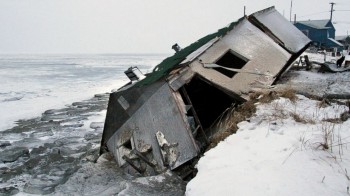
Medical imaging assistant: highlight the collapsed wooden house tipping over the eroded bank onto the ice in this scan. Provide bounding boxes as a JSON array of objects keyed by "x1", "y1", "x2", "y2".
[{"x1": 101, "y1": 7, "x2": 310, "y2": 175}]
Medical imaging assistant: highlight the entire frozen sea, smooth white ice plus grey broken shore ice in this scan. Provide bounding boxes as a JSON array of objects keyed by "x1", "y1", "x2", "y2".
[{"x1": 0, "y1": 54, "x2": 185, "y2": 196}]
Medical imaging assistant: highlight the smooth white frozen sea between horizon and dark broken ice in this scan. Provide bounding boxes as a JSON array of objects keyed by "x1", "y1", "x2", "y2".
[{"x1": 0, "y1": 54, "x2": 165, "y2": 131}]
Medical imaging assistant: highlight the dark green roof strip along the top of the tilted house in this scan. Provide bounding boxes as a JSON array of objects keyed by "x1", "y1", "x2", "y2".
[{"x1": 135, "y1": 17, "x2": 244, "y2": 87}]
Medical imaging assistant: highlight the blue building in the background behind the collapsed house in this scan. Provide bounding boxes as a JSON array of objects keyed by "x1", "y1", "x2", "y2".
[{"x1": 294, "y1": 19, "x2": 344, "y2": 51}]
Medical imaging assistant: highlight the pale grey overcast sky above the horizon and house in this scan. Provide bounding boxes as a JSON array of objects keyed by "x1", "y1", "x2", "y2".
[{"x1": 0, "y1": 0, "x2": 350, "y2": 53}]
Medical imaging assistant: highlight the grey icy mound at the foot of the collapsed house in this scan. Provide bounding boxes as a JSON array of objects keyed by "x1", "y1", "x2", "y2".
[{"x1": 53, "y1": 154, "x2": 185, "y2": 196}]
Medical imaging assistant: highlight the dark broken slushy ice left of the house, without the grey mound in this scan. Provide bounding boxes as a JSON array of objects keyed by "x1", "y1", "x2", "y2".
[{"x1": 0, "y1": 94, "x2": 108, "y2": 194}]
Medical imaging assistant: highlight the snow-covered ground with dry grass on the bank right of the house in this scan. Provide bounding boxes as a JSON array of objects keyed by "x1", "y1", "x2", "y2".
[{"x1": 186, "y1": 54, "x2": 350, "y2": 196}]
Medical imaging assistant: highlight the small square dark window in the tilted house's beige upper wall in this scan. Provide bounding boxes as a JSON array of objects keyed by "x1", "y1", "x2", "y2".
[{"x1": 214, "y1": 50, "x2": 248, "y2": 78}]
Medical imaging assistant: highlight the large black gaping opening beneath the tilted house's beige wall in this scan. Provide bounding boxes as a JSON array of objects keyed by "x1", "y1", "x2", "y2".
[{"x1": 181, "y1": 77, "x2": 235, "y2": 138}]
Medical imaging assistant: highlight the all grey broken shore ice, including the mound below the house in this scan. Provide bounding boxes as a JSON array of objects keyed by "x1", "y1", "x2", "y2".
[{"x1": 0, "y1": 93, "x2": 186, "y2": 195}]
